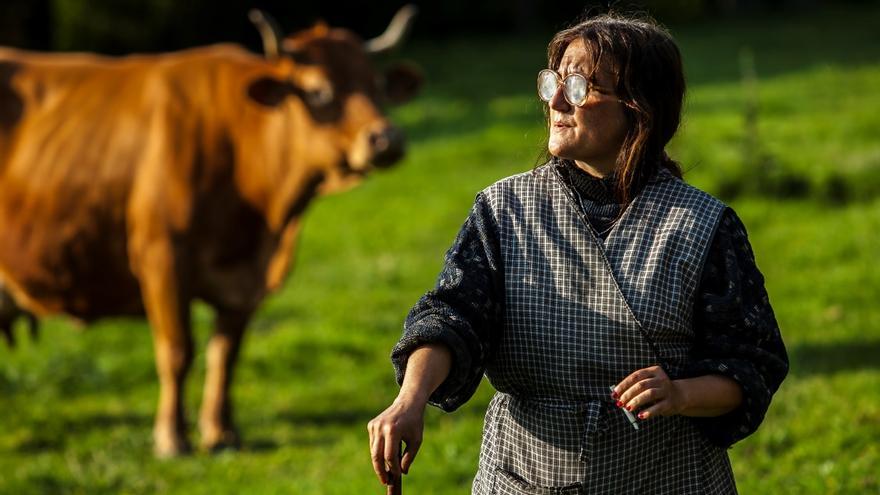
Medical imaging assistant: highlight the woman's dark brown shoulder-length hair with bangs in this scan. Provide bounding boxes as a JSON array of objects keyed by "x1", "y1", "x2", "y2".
[{"x1": 545, "y1": 14, "x2": 685, "y2": 205}]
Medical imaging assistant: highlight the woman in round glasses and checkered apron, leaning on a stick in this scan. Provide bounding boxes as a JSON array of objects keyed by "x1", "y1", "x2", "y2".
[{"x1": 368, "y1": 15, "x2": 788, "y2": 494}]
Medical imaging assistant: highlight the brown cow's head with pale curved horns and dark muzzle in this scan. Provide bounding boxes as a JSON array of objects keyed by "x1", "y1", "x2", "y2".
[{"x1": 248, "y1": 6, "x2": 422, "y2": 192}]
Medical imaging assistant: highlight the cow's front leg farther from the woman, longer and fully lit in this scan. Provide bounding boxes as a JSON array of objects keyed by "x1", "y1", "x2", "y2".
[{"x1": 139, "y1": 243, "x2": 193, "y2": 457}]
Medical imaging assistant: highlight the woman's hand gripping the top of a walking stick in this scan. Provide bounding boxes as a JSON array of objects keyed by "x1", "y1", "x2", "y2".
[{"x1": 367, "y1": 396, "x2": 426, "y2": 485}]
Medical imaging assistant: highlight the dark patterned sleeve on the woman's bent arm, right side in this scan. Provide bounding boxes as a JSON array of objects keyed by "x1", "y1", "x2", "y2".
[{"x1": 682, "y1": 208, "x2": 788, "y2": 447}]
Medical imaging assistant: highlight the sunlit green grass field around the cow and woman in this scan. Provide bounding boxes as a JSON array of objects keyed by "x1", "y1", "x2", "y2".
[{"x1": 0, "y1": 9, "x2": 880, "y2": 494}]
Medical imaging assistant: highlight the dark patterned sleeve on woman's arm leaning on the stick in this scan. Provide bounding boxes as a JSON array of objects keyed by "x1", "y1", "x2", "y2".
[{"x1": 391, "y1": 193, "x2": 504, "y2": 411}]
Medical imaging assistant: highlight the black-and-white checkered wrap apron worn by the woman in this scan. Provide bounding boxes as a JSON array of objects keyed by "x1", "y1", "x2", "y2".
[{"x1": 473, "y1": 165, "x2": 736, "y2": 495}]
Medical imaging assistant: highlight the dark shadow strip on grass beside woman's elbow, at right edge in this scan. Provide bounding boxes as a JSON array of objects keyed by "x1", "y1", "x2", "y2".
[{"x1": 789, "y1": 340, "x2": 880, "y2": 376}]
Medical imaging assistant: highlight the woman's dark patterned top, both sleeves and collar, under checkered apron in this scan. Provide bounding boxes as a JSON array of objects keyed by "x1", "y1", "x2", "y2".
[{"x1": 391, "y1": 165, "x2": 788, "y2": 447}]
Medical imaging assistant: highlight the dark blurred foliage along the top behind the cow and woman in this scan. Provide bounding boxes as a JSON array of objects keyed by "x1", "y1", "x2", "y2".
[{"x1": 0, "y1": 0, "x2": 877, "y2": 53}]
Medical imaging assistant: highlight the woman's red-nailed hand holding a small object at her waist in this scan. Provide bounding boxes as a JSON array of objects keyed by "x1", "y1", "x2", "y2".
[{"x1": 611, "y1": 366, "x2": 685, "y2": 419}]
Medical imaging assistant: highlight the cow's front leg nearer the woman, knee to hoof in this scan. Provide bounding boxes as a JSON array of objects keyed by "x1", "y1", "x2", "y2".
[{"x1": 199, "y1": 310, "x2": 251, "y2": 450}]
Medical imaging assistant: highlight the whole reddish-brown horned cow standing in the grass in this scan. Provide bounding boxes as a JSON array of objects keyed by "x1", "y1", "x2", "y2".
[{"x1": 0, "y1": 7, "x2": 421, "y2": 456}]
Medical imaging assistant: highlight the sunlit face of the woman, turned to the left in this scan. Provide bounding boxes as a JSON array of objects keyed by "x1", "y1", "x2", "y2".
[{"x1": 547, "y1": 39, "x2": 627, "y2": 177}]
